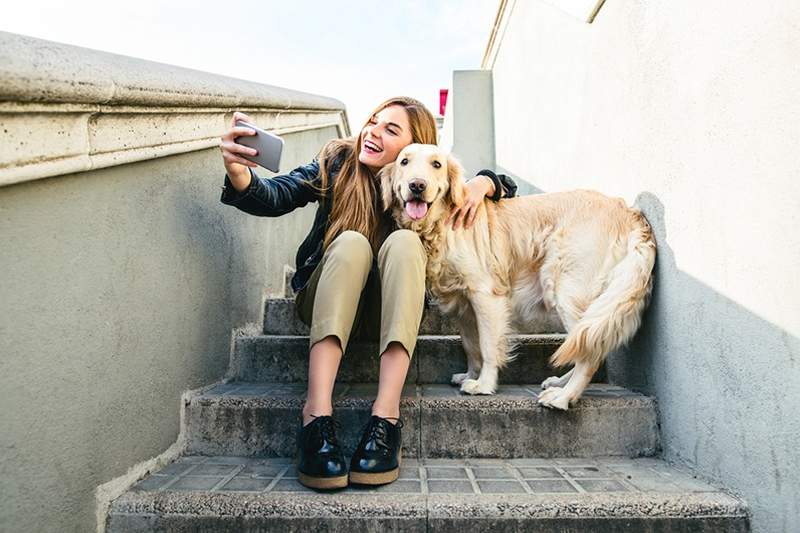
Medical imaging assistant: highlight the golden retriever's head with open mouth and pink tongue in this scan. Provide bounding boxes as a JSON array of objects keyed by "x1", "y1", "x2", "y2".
[{"x1": 379, "y1": 144, "x2": 464, "y2": 228}]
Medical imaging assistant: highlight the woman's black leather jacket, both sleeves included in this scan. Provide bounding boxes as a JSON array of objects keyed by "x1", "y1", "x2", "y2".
[{"x1": 220, "y1": 159, "x2": 517, "y2": 292}]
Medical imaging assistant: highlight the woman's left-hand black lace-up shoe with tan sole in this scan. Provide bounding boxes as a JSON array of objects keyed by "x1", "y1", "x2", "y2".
[{"x1": 297, "y1": 416, "x2": 347, "y2": 489}]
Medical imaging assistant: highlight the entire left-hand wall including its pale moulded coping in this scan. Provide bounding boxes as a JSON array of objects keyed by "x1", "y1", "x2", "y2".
[{"x1": 0, "y1": 34, "x2": 348, "y2": 532}]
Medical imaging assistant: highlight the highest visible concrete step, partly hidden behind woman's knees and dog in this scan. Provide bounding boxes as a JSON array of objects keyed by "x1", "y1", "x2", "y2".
[{"x1": 264, "y1": 298, "x2": 564, "y2": 335}]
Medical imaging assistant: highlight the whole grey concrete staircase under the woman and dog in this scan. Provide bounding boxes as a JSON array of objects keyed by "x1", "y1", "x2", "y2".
[{"x1": 107, "y1": 299, "x2": 750, "y2": 532}]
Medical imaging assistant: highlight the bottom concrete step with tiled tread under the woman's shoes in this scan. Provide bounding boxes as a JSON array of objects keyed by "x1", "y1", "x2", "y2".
[{"x1": 107, "y1": 456, "x2": 750, "y2": 533}]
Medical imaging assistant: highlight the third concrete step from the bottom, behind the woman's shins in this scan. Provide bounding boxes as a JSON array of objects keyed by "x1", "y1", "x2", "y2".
[{"x1": 231, "y1": 334, "x2": 605, "y2": 383}]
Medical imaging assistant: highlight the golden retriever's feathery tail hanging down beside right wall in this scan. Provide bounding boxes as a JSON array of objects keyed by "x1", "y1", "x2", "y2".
[{"x1": 550, "y1": 215, "x2": 656, "y2": 368}]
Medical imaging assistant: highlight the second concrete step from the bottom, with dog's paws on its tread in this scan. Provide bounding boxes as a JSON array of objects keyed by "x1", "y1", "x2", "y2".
[{"x1": 184, "y1": 382, "x2": 659, "y2": 458}]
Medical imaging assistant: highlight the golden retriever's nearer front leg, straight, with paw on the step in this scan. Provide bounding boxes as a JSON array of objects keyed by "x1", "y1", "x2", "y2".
[{"x1": 461, "y1": 292, "x2": 510, "y2": 394}]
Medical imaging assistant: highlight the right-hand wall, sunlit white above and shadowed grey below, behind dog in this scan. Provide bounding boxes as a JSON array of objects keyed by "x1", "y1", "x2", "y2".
[{"x1": 484, "y1": 0, "x2": 800, "y2": 533}]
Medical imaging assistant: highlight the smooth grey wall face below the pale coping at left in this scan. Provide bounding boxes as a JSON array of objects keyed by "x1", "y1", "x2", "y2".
[{"x1": 0, "y1": 92, "x2": 336, "y2": 531}]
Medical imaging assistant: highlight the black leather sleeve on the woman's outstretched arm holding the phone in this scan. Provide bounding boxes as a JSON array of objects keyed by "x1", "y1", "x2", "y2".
[{"x1": 220, "y1": 159, "x2": 320, "y2": 217}]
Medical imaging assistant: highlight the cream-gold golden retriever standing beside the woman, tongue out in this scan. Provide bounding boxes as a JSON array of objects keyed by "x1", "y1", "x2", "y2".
[{"x1": 379, "y1": 144, "x2": 656, "y2": 410}]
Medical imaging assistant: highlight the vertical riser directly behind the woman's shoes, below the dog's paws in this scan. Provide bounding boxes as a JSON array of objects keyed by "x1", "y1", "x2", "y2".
[{"x1": 186, "y1": 398, "x2": 658, "y2": 458}]
